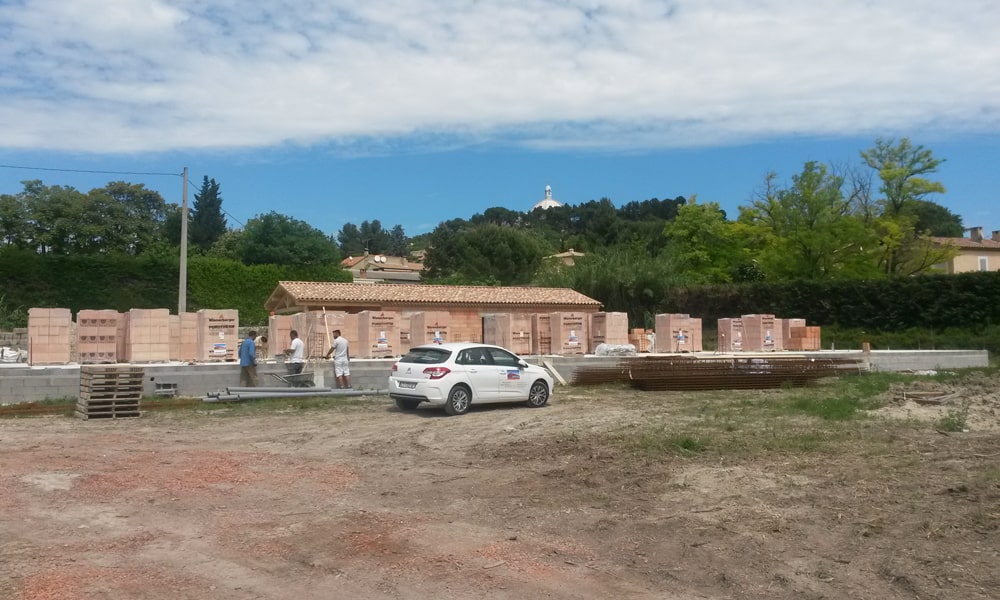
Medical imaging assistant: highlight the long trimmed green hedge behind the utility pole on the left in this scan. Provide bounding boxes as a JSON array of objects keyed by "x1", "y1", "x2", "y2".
[{"x1": 0, "y1": 249, "x2": 351, "y2": 326}]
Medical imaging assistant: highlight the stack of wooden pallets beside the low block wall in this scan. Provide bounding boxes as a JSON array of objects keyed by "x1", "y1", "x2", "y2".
[{"x1": 76, "y1": 365, "x2": 143, "y2": 419}]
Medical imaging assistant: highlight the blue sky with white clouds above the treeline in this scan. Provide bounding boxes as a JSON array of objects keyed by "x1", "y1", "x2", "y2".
[{"x1": 0, "y1": 0, "x2": 1000, "y2": 235}]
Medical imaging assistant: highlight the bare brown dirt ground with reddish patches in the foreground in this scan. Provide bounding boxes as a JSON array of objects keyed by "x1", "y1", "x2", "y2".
[{"x1": 0, "y1": 378, "x2": 1000, "y2": 600}]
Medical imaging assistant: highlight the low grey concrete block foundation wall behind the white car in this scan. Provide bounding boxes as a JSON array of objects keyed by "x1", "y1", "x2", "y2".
[{"x1": 0, "y1": 350, "x2": 989, "y2": 404}]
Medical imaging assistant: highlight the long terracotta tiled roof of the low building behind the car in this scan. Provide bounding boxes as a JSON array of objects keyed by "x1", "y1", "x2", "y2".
[{"x1": 269, "y1": 281, "x2": 601, "y2": 307}]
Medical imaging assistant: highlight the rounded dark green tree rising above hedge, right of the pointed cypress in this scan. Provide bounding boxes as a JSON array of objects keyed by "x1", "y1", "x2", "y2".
[{"x1": 239, "y1": 211, "x2": 340, "y2": 266}]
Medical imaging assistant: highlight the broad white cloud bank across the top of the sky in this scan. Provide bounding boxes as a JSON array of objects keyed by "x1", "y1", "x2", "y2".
[{"x1": 0, "y1": 0, "x2": 1000, "y2": 152}]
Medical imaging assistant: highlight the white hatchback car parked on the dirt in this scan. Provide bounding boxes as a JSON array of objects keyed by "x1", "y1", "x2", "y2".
[{"x1": 389, "y1": 343, "x2": 552, "y2": 415}]
